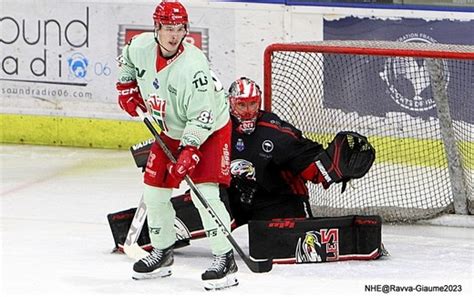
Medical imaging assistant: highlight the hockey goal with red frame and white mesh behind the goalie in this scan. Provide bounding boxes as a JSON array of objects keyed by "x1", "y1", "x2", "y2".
[{"x1": 264, "y1": 41, "x2": 474, "y2": 221}]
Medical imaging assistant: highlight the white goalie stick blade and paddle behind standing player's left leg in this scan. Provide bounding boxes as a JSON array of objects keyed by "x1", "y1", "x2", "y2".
[{"x1": 123, "y1": 195, "x2": 148, "y2": 260}]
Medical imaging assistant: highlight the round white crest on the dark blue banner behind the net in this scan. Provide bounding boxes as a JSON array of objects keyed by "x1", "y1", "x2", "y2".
[{"x1": 379, "y1": 33, "x2": 450, "y2": 111}]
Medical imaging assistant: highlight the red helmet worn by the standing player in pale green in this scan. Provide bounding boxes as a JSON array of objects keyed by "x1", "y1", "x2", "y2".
[{"x1": 153, "y1": 1, "x2": 188, "y2": 27}]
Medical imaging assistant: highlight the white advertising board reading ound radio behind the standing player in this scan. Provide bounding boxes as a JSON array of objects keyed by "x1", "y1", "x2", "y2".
[{"x1": 0, "y1": 1, "x2": 235, "y2": 119}]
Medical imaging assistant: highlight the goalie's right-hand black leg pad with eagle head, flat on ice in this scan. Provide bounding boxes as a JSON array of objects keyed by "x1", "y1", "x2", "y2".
[{"x1": 249, "y1": 216, "x2": 383, "y2": 264}]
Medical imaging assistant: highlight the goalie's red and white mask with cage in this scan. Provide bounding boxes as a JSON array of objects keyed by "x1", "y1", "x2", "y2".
[{"x1": 229, "y1": 77, "x2": 262, "y2": 134}]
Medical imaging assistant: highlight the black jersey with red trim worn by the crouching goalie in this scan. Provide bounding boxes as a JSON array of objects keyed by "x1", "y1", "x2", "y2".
[{"x1": 228, "y1": 111, "x2": 323, "y2": 223}]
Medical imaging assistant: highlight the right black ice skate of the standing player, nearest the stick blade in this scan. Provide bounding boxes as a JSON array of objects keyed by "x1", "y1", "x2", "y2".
[{"x1": 201, "y1": 250, "x2": 239, "y2": 291}]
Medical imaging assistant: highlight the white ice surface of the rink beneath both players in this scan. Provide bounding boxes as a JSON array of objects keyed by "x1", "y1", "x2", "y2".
[{"x1": 0, "y1": 145, "x2": 474, "y2": 297}]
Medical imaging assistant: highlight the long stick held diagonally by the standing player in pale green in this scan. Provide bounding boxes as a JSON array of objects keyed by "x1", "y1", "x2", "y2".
[{"x1": 137, "y1": 108, "x2": 273, "y2": 272}]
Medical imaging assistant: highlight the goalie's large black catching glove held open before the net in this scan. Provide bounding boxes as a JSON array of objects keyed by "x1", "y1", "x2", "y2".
[{"x1": 315, "y1": 132, "x2": 375, "y2": 191}]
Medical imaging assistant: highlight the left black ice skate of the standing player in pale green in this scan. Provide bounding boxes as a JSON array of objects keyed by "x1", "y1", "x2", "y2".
[{"x1": 132, "y1": 246, "x2": 174, "y2": 280}]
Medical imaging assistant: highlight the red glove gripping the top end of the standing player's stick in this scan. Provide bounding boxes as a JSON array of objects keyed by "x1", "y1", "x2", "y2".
[{"x1": 116, "y1": 80, "x2": 146, "y2": 117}]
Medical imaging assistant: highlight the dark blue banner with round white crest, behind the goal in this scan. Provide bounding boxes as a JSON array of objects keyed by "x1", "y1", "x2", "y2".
[{"x1": 324, "y1": 17, "x2": 474, "y2": 123}]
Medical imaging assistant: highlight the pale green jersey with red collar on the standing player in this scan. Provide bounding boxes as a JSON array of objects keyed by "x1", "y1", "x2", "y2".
[{"x1": 118, "y1": 33, "x2": 229, "y2": 147}]
